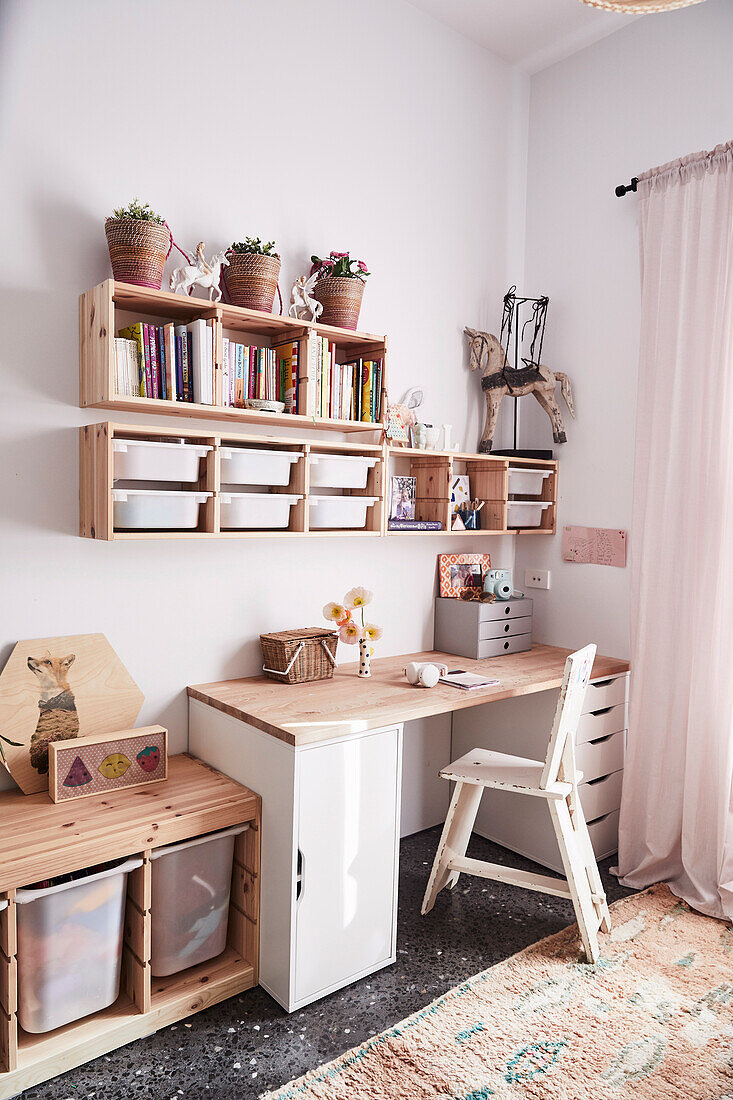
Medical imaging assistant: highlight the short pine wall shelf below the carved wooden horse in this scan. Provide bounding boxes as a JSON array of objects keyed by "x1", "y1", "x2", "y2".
[{"x1": 386, "y1": 447, "x2": 558, "y2": 538}]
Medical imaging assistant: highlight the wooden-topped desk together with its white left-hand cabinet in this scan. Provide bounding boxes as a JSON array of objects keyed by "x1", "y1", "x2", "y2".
[{"x1": 188, "y1": 646, "x2": 630, "y2": 1011}]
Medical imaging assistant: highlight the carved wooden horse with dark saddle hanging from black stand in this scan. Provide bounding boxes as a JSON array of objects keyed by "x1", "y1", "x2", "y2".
[{"x1": 463, "y1": 328, "x2": 576, "y2": 454}]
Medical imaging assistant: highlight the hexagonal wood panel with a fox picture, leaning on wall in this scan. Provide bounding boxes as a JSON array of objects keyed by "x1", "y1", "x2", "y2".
[{"x1": 0, "y1": 634, "x2": 145, "y2": 794}]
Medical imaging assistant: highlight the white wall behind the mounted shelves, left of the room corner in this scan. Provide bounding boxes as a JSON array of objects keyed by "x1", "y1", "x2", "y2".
[{"x1": 0, "y1": 0, "x2": 524, "y2": 787}]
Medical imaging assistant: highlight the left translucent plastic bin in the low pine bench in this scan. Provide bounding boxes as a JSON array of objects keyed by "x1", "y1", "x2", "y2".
[{"x1": 15, "y1": 859, "x2": 142, "y2": 1034}]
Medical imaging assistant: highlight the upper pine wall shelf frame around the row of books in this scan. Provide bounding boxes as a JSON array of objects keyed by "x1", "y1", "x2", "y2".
[{"x1": 79, "y1": 279, "x2": 387, "y2": 433}]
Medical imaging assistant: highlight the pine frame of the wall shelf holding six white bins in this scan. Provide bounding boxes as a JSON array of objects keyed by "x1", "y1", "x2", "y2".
[{"x1": 79, "y1": 421, "x2": 385, "y2": 541}]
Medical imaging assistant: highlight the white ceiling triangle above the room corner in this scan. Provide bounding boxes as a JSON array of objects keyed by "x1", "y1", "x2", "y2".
[{"x1": 409, "y1": 0, "x2": 638, "y2": 73}]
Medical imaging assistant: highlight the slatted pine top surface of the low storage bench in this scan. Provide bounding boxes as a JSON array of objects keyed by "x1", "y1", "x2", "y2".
[{"x1": 0, "y1": 754, "x2": 260, "y2": 893}]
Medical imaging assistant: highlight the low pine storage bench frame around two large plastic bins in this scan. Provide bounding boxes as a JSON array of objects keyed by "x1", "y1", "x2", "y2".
[{"x1": 0, "y1": 755, "x2": 261, "y2": 1100}]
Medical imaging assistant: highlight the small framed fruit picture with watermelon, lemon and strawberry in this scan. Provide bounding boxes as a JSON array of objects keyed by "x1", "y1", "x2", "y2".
[{"x1": 48, "y1": 726, "x2": 168, "y2": 802}]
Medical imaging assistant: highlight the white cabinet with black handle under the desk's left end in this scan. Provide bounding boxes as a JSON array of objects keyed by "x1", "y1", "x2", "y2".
[{"x1": 189, "y1": 700, "x2": 402, "y2": 1012}]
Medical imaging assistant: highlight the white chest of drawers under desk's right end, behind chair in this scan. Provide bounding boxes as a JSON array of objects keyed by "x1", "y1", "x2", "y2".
[{"x1": 451, "y1": 672, "x2": 628, "y2": 873}]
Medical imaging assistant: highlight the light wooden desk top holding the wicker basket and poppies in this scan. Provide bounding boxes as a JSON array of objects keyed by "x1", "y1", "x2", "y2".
[{"x1": 188, "y1": 646, "x2": 630, "y2": 747}]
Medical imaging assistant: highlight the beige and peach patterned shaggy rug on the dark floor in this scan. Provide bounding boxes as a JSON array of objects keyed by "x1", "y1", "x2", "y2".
[{"x1": 267, "y1": 886, "x2": 733, "y2": 1100}]
